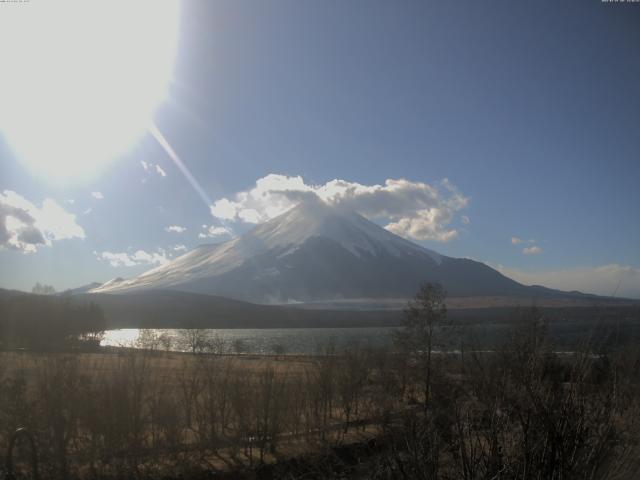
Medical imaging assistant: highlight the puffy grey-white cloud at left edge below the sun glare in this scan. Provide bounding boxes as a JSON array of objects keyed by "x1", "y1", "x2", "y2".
[{"x1": 0, "y1": 190, "x2": 85, "y2": 253}]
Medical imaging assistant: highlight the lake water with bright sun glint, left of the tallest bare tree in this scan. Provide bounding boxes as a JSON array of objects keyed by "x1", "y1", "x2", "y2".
[{"x1": 101, "y1": 327, "x2": 395, "y2": 354}]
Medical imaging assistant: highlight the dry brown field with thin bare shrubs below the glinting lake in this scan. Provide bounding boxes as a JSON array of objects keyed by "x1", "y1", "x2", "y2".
[{"x1": 0, "y1": 349, "x2": 396, "y2": 478}]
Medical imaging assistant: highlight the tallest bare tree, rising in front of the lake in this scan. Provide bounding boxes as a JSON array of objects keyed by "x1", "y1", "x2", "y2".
[{"x1": 394, "y1": 283, "x2": 447, "y2": 410}]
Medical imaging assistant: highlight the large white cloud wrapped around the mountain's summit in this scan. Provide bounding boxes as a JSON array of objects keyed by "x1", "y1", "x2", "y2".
[{"x1": 211, "y1": 174, "x2": 469, "y2": 242}]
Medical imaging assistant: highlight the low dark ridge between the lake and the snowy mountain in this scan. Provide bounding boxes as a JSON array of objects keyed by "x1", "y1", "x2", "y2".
[{"x1": 0, "y1": 289, "x2": 640, "y2": 329}]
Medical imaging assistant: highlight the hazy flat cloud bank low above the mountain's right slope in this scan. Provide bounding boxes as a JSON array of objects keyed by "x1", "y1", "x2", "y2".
[{"x1": 495, "y1": 263, "x2": 640, "y2": 298}]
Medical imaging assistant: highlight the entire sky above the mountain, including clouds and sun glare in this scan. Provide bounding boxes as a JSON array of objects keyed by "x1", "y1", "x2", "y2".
[{"x1": 0, "y1": 0, "x2": 640, "y2": 298}]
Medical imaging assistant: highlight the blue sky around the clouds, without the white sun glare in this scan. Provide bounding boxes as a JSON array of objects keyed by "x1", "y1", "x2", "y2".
[{"x1": 0, "y1": 0, "x2": 640, "y2": 297}]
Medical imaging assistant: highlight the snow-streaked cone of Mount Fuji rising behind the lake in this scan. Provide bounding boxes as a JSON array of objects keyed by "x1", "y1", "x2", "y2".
[{"x1": 91, "y1": 202, "x2": 576, "y2": 303}]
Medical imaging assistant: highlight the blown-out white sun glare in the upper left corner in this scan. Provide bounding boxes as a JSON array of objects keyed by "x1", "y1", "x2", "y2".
[{"x1": 0, "y1": 0, "x2": 179, "y2": 183}]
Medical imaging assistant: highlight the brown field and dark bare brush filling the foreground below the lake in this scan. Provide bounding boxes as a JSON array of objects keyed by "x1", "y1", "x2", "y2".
[{"x1": 0, "y1": 285, "x2": 640, "y2": 480}]
